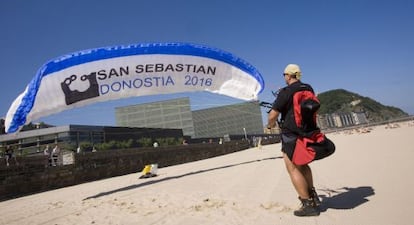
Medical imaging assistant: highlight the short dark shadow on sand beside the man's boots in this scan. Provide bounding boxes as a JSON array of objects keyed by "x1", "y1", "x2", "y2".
[{"x1": 318, "y1": 186, "x2": 375, "y2": 212}]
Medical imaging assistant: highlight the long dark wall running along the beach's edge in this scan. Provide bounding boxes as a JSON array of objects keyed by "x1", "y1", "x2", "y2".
[{"x1": 0, "y1": 141, "x2": 249, "y2": 200}]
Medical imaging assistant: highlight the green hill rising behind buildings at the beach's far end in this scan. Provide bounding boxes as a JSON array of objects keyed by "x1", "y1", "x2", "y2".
[{"x1": 318, "y1": 89, "x2": 408, "y2": 122}]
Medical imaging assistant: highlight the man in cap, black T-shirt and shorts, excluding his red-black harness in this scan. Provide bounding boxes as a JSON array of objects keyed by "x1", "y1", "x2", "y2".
[{"x1": 267, "y1": 64, "x2": 320, "y2": 216}]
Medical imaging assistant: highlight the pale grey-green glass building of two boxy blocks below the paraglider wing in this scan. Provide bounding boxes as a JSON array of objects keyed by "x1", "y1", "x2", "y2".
[{"x1": 115, "y1": 97, "x2": 263, "y2": 138}]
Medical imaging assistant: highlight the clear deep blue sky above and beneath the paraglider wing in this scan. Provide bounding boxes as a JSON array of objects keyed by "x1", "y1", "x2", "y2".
[{"x1": 0, "y1": 0, "x2": 414, "y2": 125}]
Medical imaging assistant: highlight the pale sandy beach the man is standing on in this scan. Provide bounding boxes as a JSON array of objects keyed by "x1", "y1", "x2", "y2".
[{"x1": 0, "y1": 122, "x2": 414, "y2": 225}]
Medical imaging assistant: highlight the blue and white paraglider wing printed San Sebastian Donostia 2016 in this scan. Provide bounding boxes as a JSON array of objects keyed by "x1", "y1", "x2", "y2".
[{"x1": 5, "y1": 43, "x2": 264, "y2": 133}]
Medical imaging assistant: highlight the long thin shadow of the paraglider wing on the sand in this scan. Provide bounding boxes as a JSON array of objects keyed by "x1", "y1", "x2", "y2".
[{"x1": 83, "y1": 157, "x2": 283, "y2": 201}]
